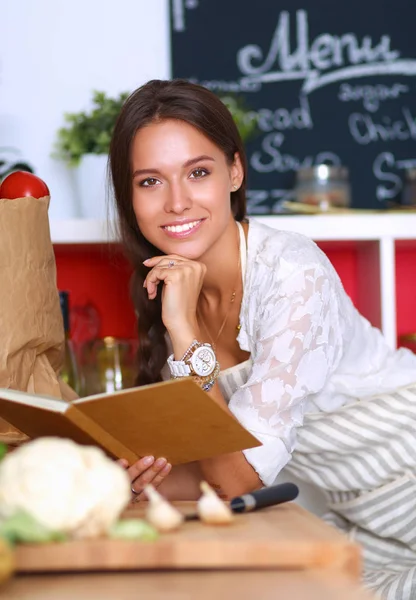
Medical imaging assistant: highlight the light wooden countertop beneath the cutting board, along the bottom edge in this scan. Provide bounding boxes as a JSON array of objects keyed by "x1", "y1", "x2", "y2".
[{"x1": 0, "y1": 571, "x2": 376, "y2": 600}]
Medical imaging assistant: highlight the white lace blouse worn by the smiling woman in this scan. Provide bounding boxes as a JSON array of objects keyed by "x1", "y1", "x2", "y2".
[{"x1": 231, "y1": 219, "x2": 416, "y2": 485}]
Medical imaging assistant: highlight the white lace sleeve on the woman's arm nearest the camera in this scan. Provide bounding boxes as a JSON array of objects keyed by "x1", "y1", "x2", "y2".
[{"x1": 229, "y1": 264, "x2": 342, "y2": 485}]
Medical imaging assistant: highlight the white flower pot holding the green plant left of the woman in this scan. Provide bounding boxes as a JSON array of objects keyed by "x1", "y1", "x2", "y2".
[{"x1": 74, "y1": 154, "x2": 114, "y2": 220}]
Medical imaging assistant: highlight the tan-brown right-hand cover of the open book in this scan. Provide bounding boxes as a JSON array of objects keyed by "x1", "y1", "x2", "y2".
[{"x1": 73, "y1": 378, "x2": 261, "y2": 464}]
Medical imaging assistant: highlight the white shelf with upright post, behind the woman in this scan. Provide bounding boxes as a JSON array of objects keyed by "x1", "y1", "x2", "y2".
[{"x1": 50, "y1": 212, "x2": 416, "y2": 348}]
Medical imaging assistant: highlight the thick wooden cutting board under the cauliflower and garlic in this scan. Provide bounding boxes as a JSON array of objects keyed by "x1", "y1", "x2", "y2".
[{"x1": 16, "y1": 503, "x2": 361, "y2": 578}]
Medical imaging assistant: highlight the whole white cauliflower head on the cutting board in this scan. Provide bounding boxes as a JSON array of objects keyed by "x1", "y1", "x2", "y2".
[{"x1": 0, "y1": 437, "x2": 131, "y2": 538}]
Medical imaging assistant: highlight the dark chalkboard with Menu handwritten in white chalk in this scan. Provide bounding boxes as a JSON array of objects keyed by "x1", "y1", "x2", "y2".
[{"x1": 170, "y1": 0, "x2": 416, "y2": 214}]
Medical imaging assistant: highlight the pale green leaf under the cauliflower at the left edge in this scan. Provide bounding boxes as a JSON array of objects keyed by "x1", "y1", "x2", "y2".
[{"x1": 0, "y1": 511, "x2": 67, "y2": 544}]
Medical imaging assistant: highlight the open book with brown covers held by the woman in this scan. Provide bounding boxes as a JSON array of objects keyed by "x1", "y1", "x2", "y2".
[{"x1": 0, "y1": 378, "x2": 261, "y2": 464}]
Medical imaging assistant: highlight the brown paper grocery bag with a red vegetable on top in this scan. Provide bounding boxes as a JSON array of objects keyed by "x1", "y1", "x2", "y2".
[{"x1": 0, "y1": 197, "x2": 64, "y2": 443}]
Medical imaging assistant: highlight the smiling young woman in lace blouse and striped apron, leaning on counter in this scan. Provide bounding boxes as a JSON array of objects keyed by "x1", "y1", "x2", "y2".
[{"x1": 110, "y1": 81, "x2": 416, "y2": 599}]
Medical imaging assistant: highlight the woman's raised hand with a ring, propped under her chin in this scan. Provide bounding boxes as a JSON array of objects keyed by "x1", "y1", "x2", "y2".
[{"x1": 144, "y1": 254, "x2": 206, "y2": 349}]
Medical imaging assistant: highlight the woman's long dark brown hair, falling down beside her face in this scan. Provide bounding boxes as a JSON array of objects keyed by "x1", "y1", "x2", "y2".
[{"x1": 109, "y1": 79, "x2": 247, "y2": 385}]
